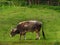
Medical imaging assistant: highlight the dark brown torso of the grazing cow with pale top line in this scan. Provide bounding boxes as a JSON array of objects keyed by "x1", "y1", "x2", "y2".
[{"x1": 17, "y1": 21, "x2": 41, "y2": 31}]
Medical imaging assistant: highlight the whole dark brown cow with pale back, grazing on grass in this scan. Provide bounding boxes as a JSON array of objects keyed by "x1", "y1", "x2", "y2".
[{"x1": 10, "y1": 20, "x2": 45, "y2": 40}]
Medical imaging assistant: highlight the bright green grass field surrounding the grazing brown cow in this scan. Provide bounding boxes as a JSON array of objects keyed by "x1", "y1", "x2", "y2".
[{"x1": 0, "y1": 5, "x2": 60, "y2": 45}]
